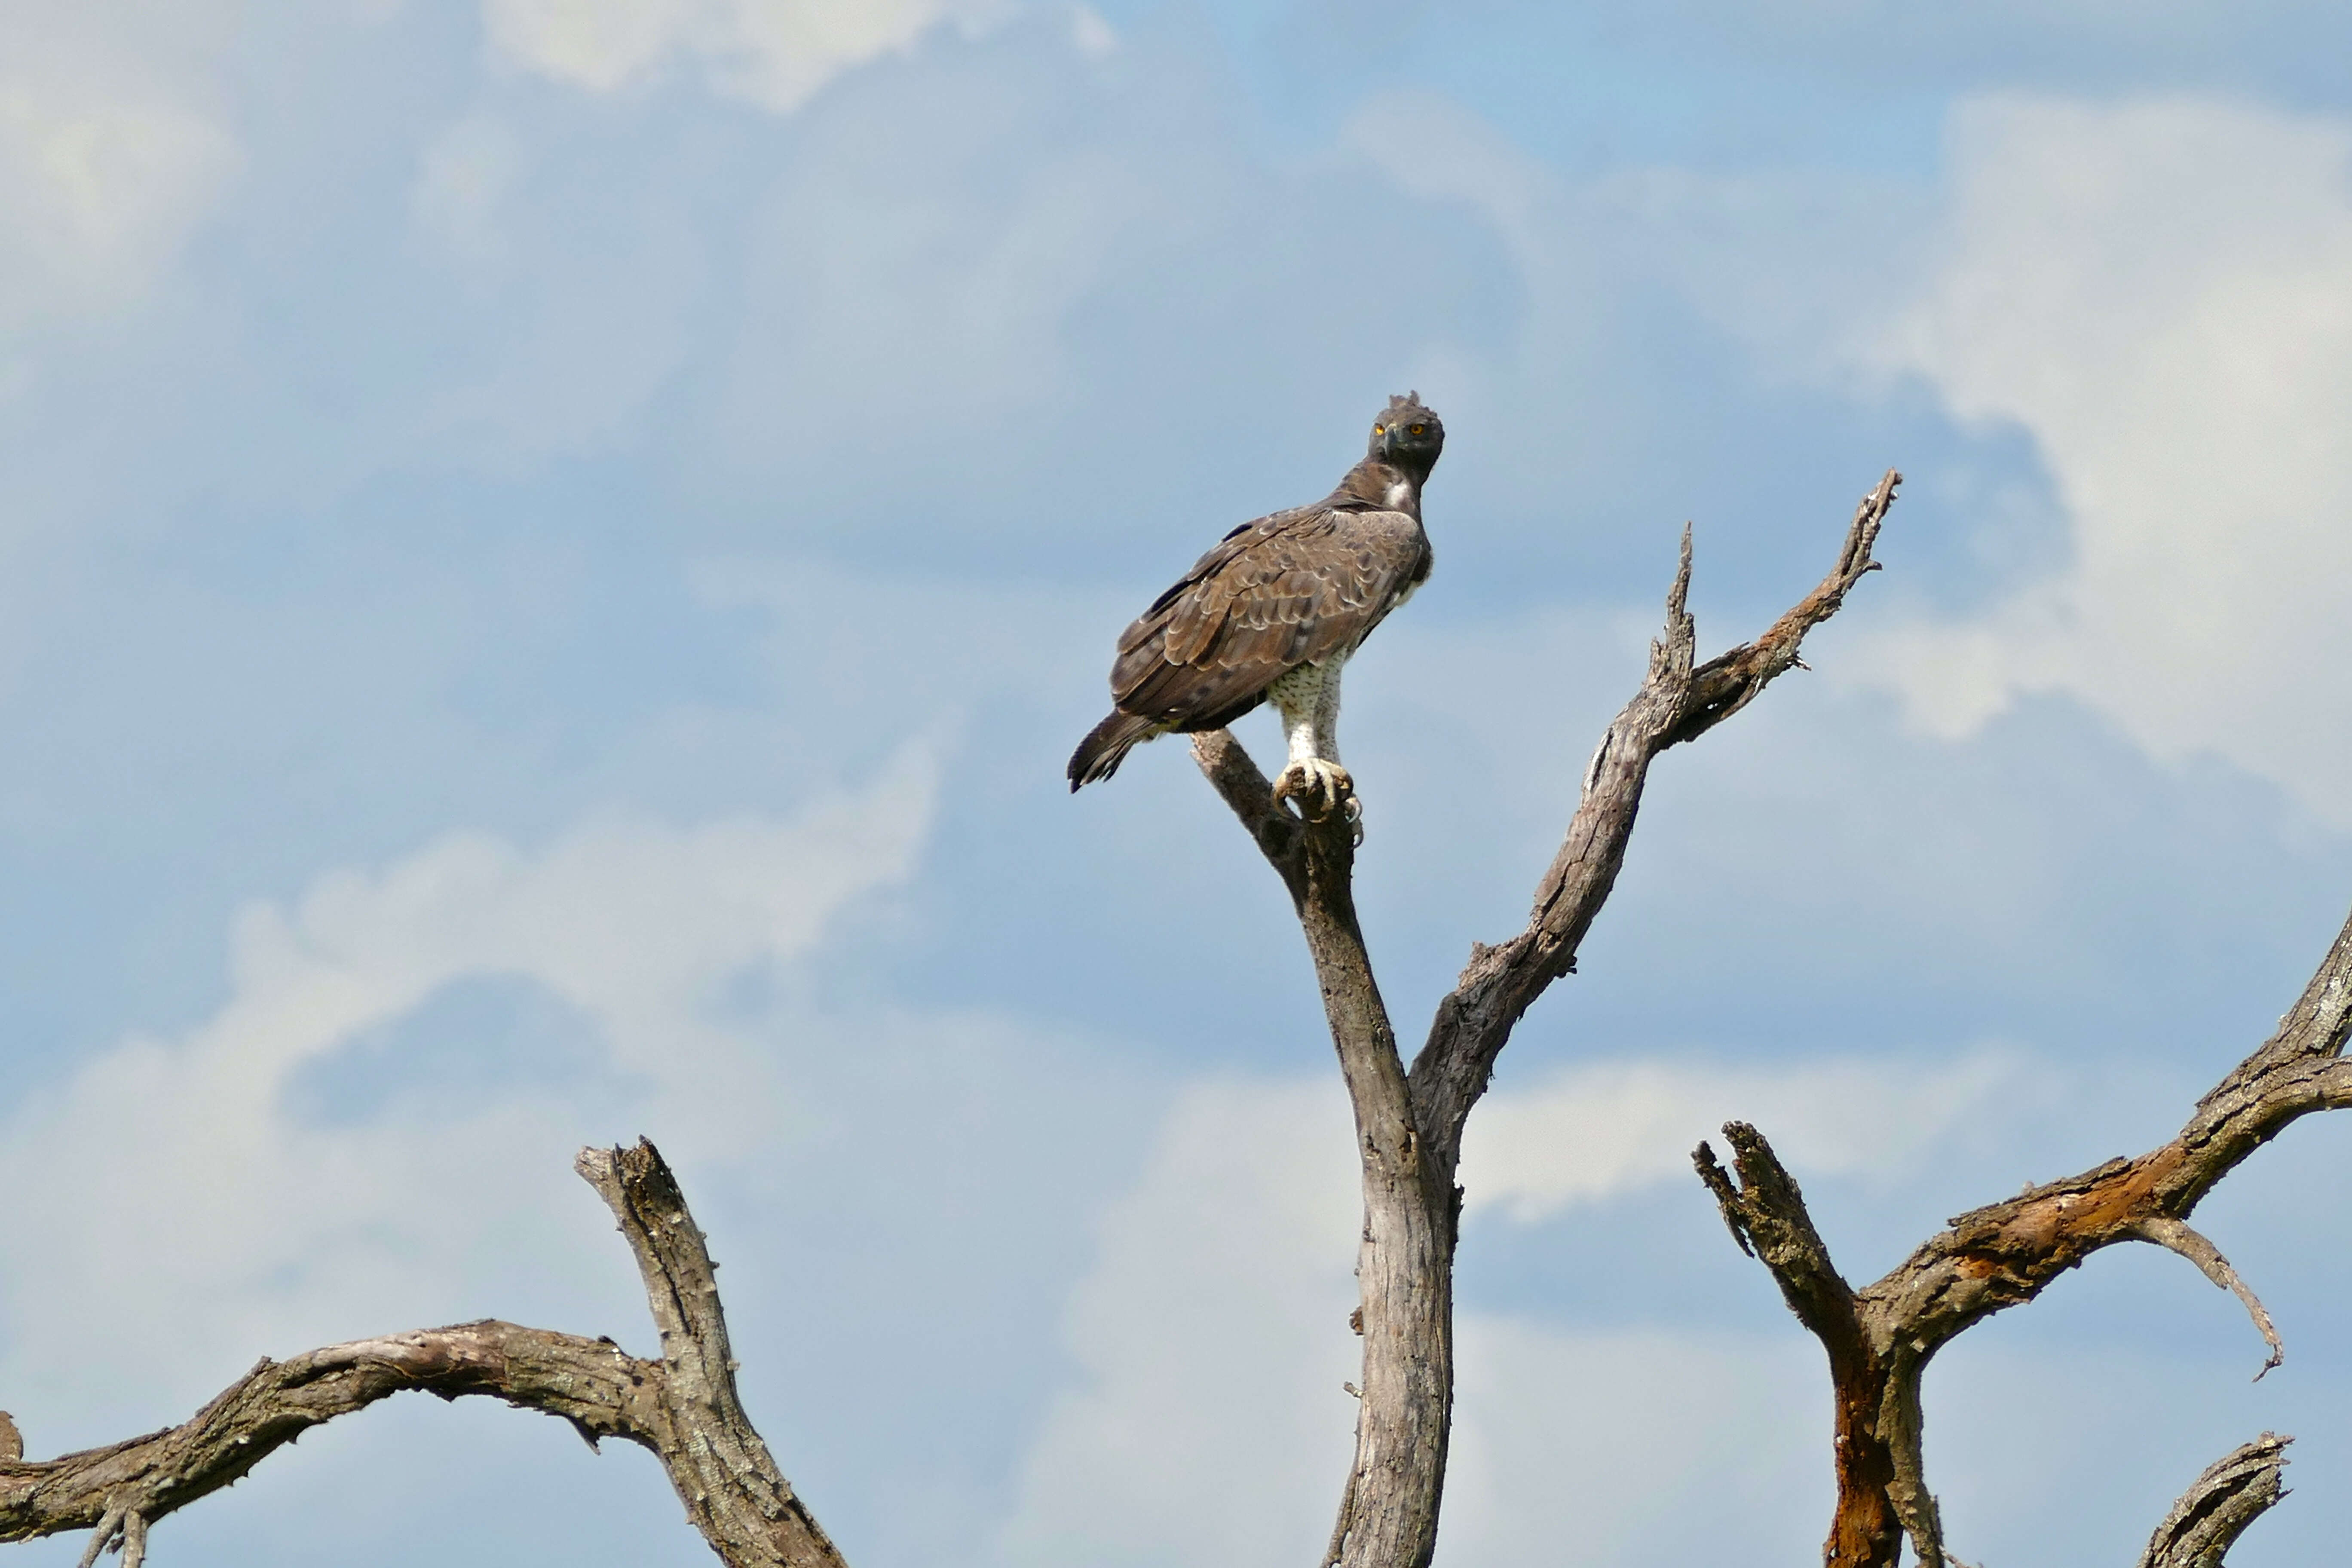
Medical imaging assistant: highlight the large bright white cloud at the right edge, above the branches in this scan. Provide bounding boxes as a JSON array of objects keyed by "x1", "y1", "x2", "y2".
[{"x1": 1858, "y1": 99, "x2": 2352, "y2": 825}]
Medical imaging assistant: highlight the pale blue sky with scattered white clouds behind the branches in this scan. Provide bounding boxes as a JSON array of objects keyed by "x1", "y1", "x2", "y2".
[{"x1": 0, "y1": 0, "x2": 2352, "y2": 1568}]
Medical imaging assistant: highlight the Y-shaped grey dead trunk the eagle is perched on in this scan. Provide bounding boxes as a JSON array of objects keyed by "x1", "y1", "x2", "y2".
[{"x1": 1192, "y1": 472, "x2": 1903, "y2": 1568}]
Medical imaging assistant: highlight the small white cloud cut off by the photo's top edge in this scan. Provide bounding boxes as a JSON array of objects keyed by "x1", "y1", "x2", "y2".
[{"x1": 482, "y1": 0, "x2": 978, "y2": 113}]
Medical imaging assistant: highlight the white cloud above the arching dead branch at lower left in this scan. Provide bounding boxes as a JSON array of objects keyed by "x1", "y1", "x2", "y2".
[{"x1": 0, "y1": 752, "x2": 931, "y2": 1436}]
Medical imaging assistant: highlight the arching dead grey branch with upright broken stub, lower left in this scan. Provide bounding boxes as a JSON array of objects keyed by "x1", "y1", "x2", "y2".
[{"x1": 0, "y1": 1140, "x2": 842, "y2": 1568}]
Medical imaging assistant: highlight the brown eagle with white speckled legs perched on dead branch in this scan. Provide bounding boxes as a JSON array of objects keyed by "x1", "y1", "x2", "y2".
[{"x1": 1070, "y1": 392, "x2": 1446, "y2": 811}]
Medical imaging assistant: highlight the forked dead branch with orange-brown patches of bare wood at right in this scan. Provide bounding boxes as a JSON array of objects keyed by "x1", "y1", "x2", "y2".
[{"x1": 1696, "y1": 903, "x2": 2352, "y2": 1568}]
